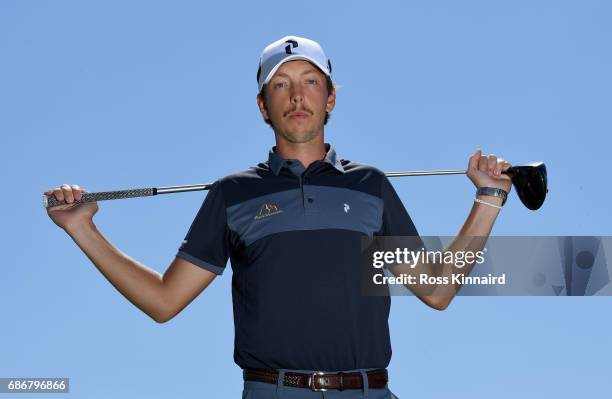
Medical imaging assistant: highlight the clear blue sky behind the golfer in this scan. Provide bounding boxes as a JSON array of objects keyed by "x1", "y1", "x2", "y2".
[{"x1": 0, "y1": 1, "x2": 612, "y2": 399}]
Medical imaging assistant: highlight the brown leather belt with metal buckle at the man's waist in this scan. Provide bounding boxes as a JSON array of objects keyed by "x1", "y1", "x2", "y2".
[{"x1": 242, "y1": 369, "x2": 388, "y2": 391}]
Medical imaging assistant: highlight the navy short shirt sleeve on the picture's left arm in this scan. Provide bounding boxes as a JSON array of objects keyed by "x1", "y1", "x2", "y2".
[{"x1": 176, "y1": 180, "x2": 231, "y2": 275}]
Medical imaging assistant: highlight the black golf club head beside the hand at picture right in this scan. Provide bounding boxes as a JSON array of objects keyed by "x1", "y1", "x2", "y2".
[{"x1": 505, "y1": 162, "x2": 548, "y2": 211}]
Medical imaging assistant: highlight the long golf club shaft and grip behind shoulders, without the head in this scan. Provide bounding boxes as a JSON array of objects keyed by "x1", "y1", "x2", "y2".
[{"x1": 43, "y1": 170, "x2": 504, "y2": 208}]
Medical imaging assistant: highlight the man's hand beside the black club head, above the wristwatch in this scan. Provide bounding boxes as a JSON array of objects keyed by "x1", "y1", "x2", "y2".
[{"x1": 467, "y1": 148, "x2": 512, "y2": 193}]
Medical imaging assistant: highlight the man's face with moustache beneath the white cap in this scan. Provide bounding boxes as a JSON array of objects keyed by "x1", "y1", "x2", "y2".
[{"x1": 257, "y1": 60, "x2": 336, "y2": 143}]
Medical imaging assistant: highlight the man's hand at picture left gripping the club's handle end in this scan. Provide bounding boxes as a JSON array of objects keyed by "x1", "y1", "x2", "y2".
[{"x1": 45, "y1": 184, "x2": 98, "y2": 232}]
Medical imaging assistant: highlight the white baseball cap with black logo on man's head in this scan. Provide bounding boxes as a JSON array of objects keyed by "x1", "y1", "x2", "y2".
[{"x1": 257, "y1": 36, "x2": 331, "y2": 91}]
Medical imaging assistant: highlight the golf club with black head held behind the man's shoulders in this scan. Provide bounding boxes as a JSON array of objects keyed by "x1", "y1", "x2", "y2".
[{"x1": 43, "y1": 162, "x2": 548, "y2": 211}]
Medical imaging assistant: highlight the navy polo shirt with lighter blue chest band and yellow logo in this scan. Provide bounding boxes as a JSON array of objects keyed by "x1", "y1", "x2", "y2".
[{"x1": 177, "y1": 143, "x2": 418, "y2": 371}]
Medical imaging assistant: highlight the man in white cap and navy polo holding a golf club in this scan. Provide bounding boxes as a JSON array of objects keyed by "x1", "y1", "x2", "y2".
[{"x1": 47, "y1": 36, "x2": 511, "y2": 399}]
